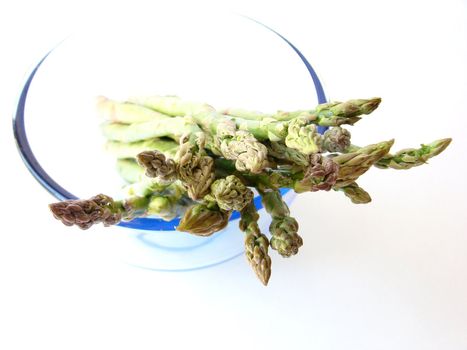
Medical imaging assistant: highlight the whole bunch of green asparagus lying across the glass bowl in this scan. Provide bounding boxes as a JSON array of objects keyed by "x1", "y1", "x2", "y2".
[{"x1": 50, "y1": 96, "x2": 451, "y2": 285}]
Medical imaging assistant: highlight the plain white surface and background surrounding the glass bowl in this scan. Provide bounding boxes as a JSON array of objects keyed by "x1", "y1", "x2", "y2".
[{"x1": 0, "y1": 1, "x2": 467, "y2": 350}]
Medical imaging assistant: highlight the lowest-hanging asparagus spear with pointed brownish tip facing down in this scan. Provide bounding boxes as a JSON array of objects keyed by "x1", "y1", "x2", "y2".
[{"x1": 239, "y1": 202, "x2": 271, "y2": 286}]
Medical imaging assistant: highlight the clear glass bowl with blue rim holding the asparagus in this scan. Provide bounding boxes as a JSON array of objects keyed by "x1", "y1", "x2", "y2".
[{"x1": 14, "y1": 13, "x2": 326, "y2": 271}]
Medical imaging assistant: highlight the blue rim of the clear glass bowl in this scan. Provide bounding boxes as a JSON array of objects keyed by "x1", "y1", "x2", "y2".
[{"x1": 13, "y1": 16, "x2": 327, "y2": 231}]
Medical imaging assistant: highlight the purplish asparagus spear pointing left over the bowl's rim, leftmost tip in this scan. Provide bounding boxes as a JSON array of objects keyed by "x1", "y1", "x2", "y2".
[{"x1": 49, "y1": 194, "x2": 148, "y2": 230}]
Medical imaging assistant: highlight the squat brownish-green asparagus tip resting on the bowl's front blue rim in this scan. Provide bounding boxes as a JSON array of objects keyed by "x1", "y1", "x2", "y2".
[{"x1": 177, "y1": 203, "x2": 232, "y2": 236}]
